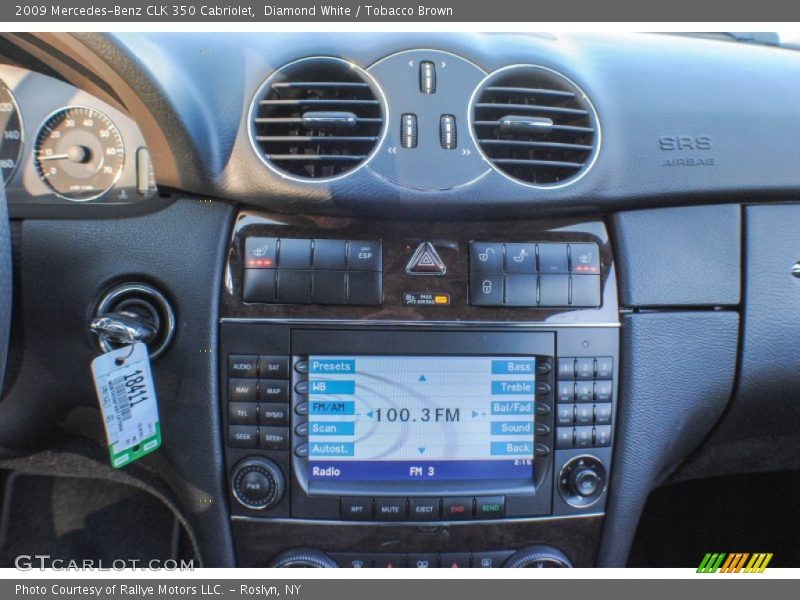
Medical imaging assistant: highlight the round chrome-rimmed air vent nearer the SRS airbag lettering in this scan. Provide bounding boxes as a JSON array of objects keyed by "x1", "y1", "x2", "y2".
[{"x1": 470, "y1": 65, "x2": 600, "y2": 188}]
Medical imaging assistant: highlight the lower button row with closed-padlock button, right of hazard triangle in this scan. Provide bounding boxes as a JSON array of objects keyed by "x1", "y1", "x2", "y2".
[{"x1": 469, "y1": 271, "x2": 600, "y2": 308}]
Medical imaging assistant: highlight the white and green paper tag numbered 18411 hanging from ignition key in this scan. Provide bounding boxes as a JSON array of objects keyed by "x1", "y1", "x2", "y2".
[{"x1": 92, "y1": 343, "x2": 161, "y2": 469}]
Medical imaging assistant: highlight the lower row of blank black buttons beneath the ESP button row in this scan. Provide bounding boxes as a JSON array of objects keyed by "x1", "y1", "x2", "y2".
[{"x1": 242, "y1": 269, "x2": 383, "y2": 306}]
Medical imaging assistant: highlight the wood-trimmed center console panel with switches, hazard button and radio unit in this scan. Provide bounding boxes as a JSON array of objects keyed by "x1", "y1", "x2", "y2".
[{"x1": 220, "y1": 213, "x2": 619, "y2": 567}]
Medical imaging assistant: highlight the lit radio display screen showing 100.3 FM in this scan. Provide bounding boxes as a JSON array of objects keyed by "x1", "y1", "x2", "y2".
[{"x1": 308, "y1": 356, "x2": 536, "y2": 482}]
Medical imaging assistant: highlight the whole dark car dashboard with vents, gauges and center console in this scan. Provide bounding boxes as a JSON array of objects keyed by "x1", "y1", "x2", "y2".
[{"x1": 0, "y1": 33, "x2": 800, "y2": 568}]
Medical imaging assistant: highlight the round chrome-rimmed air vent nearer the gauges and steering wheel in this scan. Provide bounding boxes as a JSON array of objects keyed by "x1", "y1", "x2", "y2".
[{"x1": 250, "y1": 57, "x2": 385, "y2": 181}]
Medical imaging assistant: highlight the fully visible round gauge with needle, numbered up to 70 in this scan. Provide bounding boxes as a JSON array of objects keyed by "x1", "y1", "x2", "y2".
[{"x1": 34, "y1": 106, "x2": 125, "y2": 202}]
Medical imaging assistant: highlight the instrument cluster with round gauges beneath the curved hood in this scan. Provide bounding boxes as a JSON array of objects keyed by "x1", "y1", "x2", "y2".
[{"x1": 0, "y1": 64, "x2": 156, "y2": 210}]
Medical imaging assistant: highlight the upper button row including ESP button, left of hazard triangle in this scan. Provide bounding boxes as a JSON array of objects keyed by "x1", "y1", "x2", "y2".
[{"x1": 244, "y1": 237, "x2": 383, "y2": 271}]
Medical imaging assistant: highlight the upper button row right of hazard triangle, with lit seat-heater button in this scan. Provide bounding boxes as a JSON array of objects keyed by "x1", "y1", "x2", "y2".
[{"x1": 469, "y1": 242, "x2": 600, "y2": 275}]
